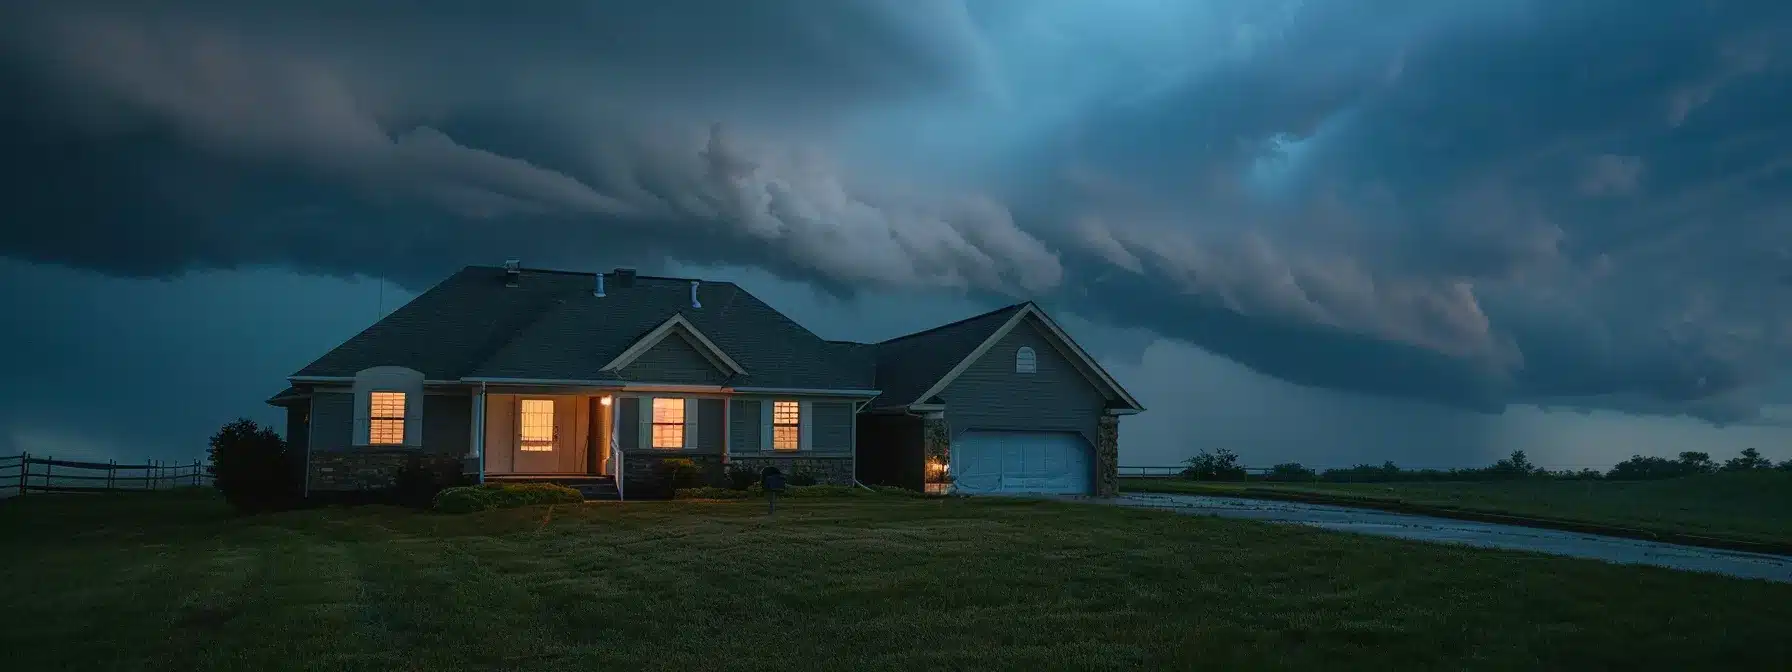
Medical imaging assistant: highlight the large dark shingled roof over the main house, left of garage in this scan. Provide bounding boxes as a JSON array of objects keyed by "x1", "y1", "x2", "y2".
[{"x1": 297, "y1": 267, "x2": 874, "y2": 389}]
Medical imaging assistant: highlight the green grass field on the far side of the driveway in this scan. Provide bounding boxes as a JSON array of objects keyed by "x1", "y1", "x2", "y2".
[{"x1": 1120, "y1": 471, "x2": 1792, "y2": 543}]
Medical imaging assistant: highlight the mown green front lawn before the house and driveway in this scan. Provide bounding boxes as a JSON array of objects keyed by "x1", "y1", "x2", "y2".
[{"x1": 0, "y1": 493, "x2": 1792, "y2": 670}]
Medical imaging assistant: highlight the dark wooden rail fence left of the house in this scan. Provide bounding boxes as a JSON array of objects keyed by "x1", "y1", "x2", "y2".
[{"x1": 0, "y1": 453, "x2": 211, "y2": 495}]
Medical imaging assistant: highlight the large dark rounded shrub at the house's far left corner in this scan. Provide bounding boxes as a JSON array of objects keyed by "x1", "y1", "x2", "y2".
[{"x1": 206, "y1": 418, "x2": 303, "y2": 513}]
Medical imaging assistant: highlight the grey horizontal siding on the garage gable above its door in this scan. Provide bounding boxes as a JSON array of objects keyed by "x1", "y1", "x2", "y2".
[{"x1": 941, "y1": 317, "x2": 1107, "y2": 446}]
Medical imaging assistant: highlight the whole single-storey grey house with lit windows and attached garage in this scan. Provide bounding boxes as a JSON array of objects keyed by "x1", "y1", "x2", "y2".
[{"x1": 269, "y1": 262, "x2": 1143, "y2": 498}]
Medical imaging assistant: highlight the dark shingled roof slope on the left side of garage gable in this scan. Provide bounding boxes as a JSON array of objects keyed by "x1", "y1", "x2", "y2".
[{"x1": 873, "y1": 303, "x2": 1027, "y2": 407}]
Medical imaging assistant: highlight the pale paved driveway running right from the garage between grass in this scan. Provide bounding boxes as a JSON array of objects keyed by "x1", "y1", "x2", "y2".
[{"x1": 1113, "y1": 493, "x2": 1792, "y2": 582}]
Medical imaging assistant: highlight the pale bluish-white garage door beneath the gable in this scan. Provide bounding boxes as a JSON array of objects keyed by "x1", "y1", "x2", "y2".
[{"x1": 952, "y1": 430, "x2": 1093, "y2": 495}]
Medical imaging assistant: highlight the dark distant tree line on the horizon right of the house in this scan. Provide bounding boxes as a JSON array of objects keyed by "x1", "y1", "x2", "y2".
[{"x1": 1183, "y1": 448, "x2": 1792, "y2": 482}]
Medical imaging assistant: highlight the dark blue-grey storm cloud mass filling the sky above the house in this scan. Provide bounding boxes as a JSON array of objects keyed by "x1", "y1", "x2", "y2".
[{"x1": 0, "y1": 0, "x2": 1792, "y2": 421}]
